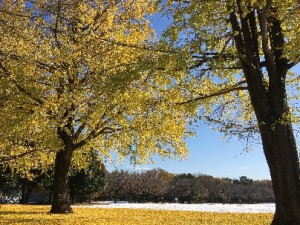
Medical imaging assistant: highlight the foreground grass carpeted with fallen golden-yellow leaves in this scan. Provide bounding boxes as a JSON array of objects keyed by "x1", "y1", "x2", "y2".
[{"x1": 0, "y1": 205, "x2": 273, "y2": 225}]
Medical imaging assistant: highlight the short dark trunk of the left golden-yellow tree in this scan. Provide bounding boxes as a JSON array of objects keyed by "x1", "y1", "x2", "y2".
[{"x1": 50, "y1": 147, "x2": 73, "y2": 214}]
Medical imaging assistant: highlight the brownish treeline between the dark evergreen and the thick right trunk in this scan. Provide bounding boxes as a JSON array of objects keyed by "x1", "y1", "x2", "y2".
[{"x1": 99, "y1": 169, "x2": 274, "y2": 203}]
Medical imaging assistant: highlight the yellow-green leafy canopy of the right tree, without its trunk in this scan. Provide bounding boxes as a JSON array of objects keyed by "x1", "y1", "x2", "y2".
[{"x1": 161, "y1": 0, "x2": 300, "y2": 139}]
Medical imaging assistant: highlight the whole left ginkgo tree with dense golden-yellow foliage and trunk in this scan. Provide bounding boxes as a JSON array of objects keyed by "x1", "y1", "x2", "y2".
[{"x1": 0, "y1": 0, "x2": 192, "y2": 213}]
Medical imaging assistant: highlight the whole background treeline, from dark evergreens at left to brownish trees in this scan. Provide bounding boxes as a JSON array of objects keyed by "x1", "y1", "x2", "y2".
[{"x1": 0, "y1": 164, "x2": 274, "y2": 203}]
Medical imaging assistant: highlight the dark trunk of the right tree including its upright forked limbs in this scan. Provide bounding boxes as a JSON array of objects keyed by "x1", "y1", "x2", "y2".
[{"x1": 230, "y1": 0, "x2": 300, "y2": 225}]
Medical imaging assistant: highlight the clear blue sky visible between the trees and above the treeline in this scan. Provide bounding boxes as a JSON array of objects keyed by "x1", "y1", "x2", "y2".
[{"x1": 107, "y1": 12, "x2": 300, "y2": 180}]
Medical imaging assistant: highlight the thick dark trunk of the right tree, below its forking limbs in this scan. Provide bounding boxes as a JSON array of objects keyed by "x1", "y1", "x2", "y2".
[{"x1": 244, "y1": 62, "x2": 300, "y2": 225}]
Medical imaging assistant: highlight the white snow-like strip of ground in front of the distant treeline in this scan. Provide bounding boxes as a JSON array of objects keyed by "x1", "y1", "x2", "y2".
[{"x1": 75, "y1": 202, "x2": 275, "y2": 213}]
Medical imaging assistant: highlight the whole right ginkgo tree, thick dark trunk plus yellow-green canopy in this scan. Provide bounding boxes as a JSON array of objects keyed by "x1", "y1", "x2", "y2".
[{"x1": 162, "y1": 0, "x2": 300, "y2": 225}]
